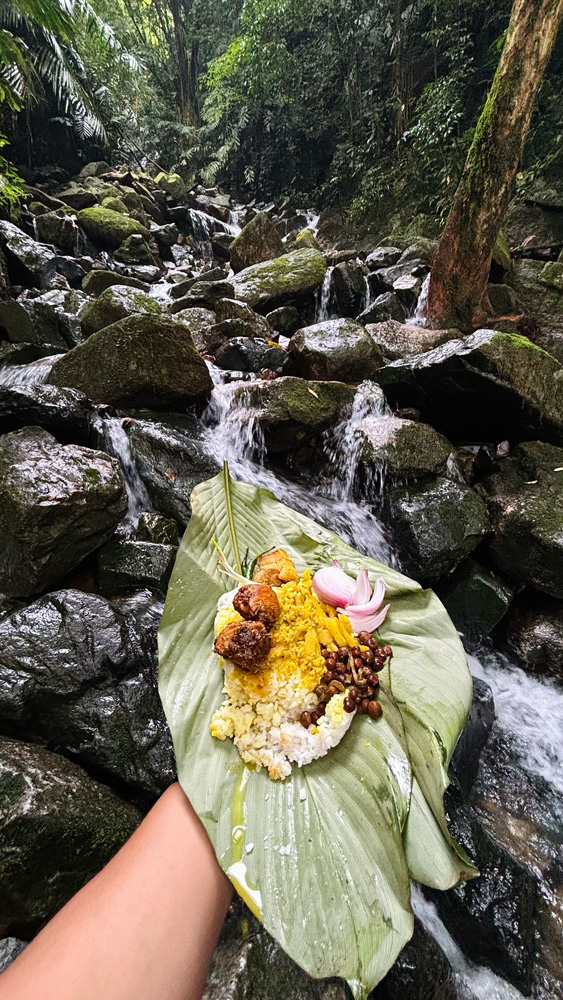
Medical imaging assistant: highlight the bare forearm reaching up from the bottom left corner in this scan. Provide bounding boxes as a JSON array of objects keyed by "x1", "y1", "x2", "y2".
[{"x1": 0, "y1": 784, "x2": 232, "y2": 1000}]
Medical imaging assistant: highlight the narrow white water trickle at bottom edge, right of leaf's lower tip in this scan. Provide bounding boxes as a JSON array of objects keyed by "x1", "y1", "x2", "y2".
[{"x1": 411, "y1": 884, "x2": 524, "y2": 1000}]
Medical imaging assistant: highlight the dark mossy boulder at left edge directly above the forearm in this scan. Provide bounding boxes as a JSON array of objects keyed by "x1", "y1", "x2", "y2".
[{"x1": 0, "y1": 737, "x2": 141, "y2": 934}]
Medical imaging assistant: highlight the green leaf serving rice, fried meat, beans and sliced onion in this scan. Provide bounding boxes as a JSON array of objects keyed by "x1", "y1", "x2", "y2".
[{"x1": 159, "y1": 467, "x2": 477, "y2": 998}]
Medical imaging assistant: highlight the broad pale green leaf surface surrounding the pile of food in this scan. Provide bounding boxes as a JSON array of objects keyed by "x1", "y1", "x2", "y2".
[{"x1": 159, "y1": 469, "x2": 478, "y2": 1000}]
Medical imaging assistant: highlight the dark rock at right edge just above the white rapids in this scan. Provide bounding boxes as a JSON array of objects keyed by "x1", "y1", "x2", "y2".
[{"x1": 506, "y1": 591, "x2": 563, "y2": 679}]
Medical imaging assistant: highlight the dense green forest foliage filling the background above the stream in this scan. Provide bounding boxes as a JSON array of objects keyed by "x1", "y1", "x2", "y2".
[{"x1": 0, "y1": 0, "x2": 563, "y2": 235}]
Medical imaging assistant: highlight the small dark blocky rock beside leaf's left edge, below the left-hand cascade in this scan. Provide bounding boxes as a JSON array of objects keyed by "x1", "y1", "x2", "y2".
[{"x1": 98, "y1": 540, "x2": 178, "y2": 596}]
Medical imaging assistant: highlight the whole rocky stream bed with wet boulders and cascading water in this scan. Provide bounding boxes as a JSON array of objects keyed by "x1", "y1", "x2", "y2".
[{"x1": 0, "y1": 163, "x2": 563, "y2": 1000}]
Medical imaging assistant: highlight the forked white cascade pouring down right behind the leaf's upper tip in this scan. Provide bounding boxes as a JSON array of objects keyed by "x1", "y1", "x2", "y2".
[{"x1": 203, "y1": 382, "x2": 396, "y2": 565}]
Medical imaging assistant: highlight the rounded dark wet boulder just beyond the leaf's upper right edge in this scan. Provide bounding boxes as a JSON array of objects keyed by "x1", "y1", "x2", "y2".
[{"x1": 383, "y1": 477, "x2": 490, "y2": 580}]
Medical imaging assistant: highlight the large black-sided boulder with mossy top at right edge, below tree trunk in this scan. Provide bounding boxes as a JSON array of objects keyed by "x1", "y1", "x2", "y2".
[{"x1": 377, "y1": 330, "x2": 563, "y2": 442}]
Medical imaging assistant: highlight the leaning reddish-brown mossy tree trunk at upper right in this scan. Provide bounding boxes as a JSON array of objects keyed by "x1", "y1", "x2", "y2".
[{"x1": 426, "y1": 0, "x2": 563, "y2": 330}]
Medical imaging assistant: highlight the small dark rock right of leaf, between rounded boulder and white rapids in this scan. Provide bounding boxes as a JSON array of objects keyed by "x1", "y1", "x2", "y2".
[{"x1": 438, "y1": 559, "x2": 514, "y2": 638}]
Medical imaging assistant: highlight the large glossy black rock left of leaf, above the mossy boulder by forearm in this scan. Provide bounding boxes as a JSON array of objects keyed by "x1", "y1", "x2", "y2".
[{"x1": 0, "y1": 592, "x2": 175, "y2": 796}]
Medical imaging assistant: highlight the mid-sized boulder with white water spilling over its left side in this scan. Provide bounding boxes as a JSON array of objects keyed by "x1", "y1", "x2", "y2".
[{"x1": 355, "y1": 415, "x2": 452, "y2": 486}]
